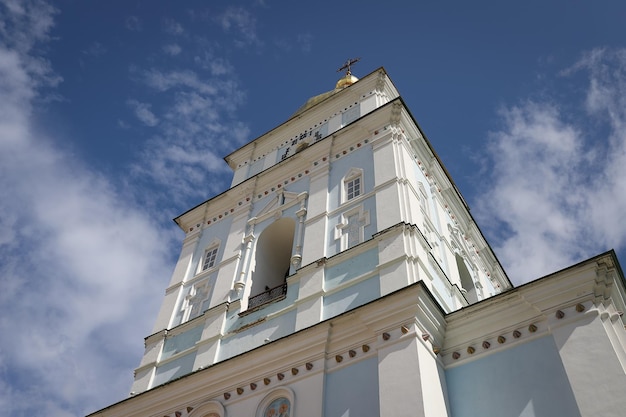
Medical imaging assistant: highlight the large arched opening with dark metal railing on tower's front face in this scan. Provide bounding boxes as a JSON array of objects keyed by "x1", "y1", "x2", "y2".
[{"x1": 248, "y1": 217, "x2": 296, "y2": 309}]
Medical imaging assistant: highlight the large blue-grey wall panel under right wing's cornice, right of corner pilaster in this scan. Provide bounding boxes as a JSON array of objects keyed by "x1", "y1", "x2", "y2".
[{"x1": 446, "y1": 336, "x2": 576, "y2": 417}]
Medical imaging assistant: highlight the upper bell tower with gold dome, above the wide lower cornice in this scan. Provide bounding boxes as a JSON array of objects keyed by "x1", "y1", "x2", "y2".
[{"x1": 132, "y1": 64, "x2": 510, "y2": 393}]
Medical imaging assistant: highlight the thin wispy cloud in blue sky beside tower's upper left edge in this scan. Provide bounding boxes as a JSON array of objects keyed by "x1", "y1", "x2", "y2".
[{"x1": 129, "y1": 68, "x2": 249, "y2": 205}]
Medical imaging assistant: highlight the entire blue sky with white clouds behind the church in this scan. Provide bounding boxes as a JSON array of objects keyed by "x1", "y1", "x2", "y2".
[{"x1": 0, "y1": 0, "x2": 626, "y2": 417}]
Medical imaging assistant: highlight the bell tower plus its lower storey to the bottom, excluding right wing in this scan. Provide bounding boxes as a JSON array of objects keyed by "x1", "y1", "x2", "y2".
[{"x1": 91, "y1": 64, "x2": 511, "y2": 417}]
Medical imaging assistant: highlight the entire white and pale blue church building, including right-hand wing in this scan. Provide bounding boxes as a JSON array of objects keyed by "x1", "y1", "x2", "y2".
[{"x1": 93, "y1": 60, "x2": 626, "y2": 417}]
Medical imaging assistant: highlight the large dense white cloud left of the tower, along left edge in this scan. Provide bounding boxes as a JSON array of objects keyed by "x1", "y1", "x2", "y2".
[{"x1": 0, "y1": 1, "x2": 172, "y2": 417}]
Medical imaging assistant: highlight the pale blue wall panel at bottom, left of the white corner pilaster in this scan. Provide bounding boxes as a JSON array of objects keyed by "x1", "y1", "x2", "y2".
[{"x1": 324, "y1": 357, "x2": 380, "y2": 417}]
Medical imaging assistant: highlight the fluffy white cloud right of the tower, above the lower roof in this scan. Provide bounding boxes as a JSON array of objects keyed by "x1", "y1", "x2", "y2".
[{"x1": 476, "y1": 49, "x2": 626, "y2": 283}]
